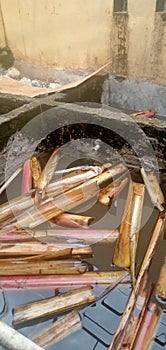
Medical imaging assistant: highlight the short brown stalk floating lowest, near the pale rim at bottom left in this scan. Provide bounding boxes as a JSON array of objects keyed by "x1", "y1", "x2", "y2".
[{"x1": 33, "y1": 310, "x2": 82, "y2": 347}]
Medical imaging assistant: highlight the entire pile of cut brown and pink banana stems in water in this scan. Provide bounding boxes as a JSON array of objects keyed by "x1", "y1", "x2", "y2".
[{"x1": 0, "y1": 148, "x2": 165, "y2": 350}]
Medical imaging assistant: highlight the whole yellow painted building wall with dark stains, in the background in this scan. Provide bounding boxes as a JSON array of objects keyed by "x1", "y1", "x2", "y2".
[{"x1": 0, "y1": 0, "x2": 166, "y2": 83}]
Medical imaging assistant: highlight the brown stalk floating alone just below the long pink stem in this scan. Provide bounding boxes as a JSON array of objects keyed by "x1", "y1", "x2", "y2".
[{"x1": 14, "y1": 286, "x2": 96, "y2": 325}]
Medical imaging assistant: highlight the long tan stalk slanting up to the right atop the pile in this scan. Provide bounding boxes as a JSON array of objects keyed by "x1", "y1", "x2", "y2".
[{"x1": 0, "y1": 164, "x2": 122, "y2": 230}]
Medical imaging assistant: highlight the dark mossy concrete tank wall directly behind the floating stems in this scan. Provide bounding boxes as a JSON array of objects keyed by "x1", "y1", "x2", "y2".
[{"x1": 0, "y1": 101, "x2": 166, "y2": 197}]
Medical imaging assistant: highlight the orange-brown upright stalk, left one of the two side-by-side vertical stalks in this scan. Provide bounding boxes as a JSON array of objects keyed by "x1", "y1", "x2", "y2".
[{"x1": 113, "y1": 182, "x2": 133, "y2": 267}]
